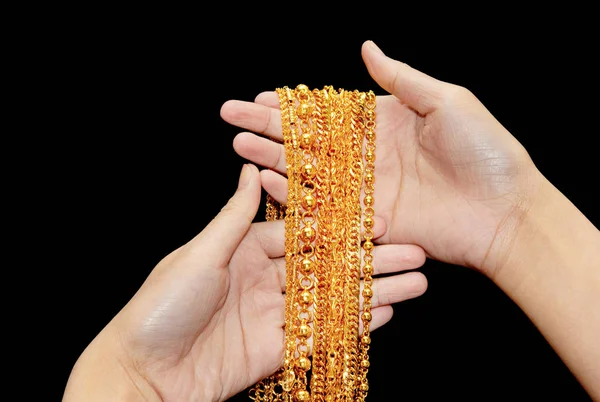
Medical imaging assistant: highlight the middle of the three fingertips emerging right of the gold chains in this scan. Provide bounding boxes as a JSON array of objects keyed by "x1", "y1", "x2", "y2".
[{"x1": 360, "y1": 272, "x2": 427, "y2": 309}]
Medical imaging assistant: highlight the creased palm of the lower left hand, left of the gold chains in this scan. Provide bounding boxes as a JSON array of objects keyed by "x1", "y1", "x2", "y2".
[{"x1": 122, "y1": 222, "x2": 284, "y2": 400}]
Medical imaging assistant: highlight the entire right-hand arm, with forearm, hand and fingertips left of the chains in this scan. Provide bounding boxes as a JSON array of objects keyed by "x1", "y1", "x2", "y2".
[{"x1": 221, "y1": 41, "x2": 600, "y2": 400}]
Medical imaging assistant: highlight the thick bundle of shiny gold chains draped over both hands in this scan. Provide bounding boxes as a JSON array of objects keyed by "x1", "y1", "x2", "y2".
[{"x1": 250, "y1": 84, "x2": 375, "y2": 402}]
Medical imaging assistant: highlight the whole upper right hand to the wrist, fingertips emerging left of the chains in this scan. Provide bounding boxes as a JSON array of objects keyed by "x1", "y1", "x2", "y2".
[{"x1": 221, "y1": 42, "x2": 541, "y2": 276}]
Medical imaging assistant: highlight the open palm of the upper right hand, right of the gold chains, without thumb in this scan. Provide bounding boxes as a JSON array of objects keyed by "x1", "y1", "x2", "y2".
[{"x1": 368, "y1": 92, "x2": 530, "y2": 267}]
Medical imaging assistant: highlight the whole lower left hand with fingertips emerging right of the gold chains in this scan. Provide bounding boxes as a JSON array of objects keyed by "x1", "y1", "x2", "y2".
[{"x1": 64, "y1": 165, "x2": 427, "y2": 401}]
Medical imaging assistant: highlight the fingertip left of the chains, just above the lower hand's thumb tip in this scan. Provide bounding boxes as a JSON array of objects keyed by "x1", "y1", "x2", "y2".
[{"x1": 233, "y1": 132, "x2": 286, "y2": 173}]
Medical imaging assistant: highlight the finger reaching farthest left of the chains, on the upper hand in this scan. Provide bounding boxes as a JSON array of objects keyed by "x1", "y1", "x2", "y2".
[{"x1": 221, "y1": 100, "x2": 283, "y2": 140}]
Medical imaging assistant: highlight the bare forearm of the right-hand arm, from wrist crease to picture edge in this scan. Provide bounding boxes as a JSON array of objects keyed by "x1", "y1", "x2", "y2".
[{"x1": 493, "y1": 179, "x2": 600, "y2": 401}]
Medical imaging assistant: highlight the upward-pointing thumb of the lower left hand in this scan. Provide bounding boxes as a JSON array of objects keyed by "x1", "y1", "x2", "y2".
[{"x1": 189, "y1": 164, "x2": 261, "y2": 267}]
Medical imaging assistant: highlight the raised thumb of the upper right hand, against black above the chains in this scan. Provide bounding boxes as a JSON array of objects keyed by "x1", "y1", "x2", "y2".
[{"x1": 362, "y1": 41, "x2": 445, "y2": 115}]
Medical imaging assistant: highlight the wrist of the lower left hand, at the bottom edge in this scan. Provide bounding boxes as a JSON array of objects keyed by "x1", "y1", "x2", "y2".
[{"x1": 63, "y1": 328, "x2": 162, "y2": 402}]
